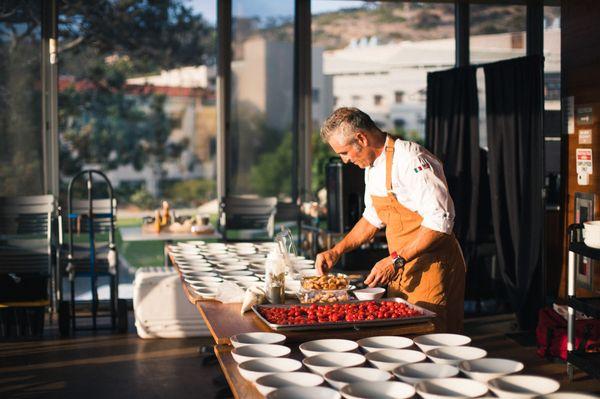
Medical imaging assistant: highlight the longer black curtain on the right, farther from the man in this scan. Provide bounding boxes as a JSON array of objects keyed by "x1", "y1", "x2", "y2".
[{"x1": 483, "y1": 56, "x2": 544, "y2": 330}]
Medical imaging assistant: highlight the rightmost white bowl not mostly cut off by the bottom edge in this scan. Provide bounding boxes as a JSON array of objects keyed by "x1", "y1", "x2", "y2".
[{"x1": 488, "y1": 374, "x2": 560, "y2": 399}]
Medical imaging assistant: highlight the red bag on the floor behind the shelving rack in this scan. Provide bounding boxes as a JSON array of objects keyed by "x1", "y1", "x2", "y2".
[{"x1": 535, "y1": 308, "x2": 600, "y2": 361}]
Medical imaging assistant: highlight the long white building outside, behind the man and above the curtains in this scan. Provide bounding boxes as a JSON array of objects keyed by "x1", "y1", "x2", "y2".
[{"x1": 323, "y1": 28, "x2": 560, "y2": 138}]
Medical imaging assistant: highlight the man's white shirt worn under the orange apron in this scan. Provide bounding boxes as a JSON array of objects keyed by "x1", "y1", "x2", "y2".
[{"x1": 363, "y1": 140, "x2": 454, "y2": 234}]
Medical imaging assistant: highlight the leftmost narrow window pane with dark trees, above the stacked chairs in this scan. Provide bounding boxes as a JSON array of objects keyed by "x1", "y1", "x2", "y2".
[{"x1": 0, "y1": 0, "x2": 44, "y2": 196}]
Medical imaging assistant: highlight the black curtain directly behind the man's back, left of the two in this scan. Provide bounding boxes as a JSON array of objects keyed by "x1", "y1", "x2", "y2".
[{"x1": 425, "y1": 66, "x2": 481, "y2": 265}]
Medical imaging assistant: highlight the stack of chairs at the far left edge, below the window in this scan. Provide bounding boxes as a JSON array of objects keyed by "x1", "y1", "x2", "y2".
[{"x1": 0, "y1": 195, "x2": 56, "y2": 338}]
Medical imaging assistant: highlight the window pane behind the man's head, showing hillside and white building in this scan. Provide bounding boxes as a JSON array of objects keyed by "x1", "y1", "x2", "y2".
[{"x1": 311, "y1": 0, "x2": 455, "y2": 191}]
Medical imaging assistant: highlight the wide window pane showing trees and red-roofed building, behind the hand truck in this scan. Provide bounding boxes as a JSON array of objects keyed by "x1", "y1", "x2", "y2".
[{"x1": 59, "y1": 0, "x2": 216, "y2": 214}]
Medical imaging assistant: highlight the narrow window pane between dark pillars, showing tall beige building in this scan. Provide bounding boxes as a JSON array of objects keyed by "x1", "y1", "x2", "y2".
[{"x1": 227, "y1": 0, "x2": 296, "y2": 201}]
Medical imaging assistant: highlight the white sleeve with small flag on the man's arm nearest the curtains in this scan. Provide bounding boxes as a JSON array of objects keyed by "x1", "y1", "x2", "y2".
[{"x1": 405, "y1": 153, "x2": 454, "y2": 234}]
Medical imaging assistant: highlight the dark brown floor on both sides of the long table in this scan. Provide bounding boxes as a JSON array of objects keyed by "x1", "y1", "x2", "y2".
[{"x1": 0, "y1": 315, "x2": 600, "y2": 399}]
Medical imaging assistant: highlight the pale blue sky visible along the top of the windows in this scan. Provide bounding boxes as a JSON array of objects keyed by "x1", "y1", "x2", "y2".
[{"x1": 187, "y1": 0, "x2": 363, "y2": 23}]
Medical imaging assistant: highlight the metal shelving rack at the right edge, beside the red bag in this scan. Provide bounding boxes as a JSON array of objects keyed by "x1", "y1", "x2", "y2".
[{"x1": 567, "y1": 223, "x2": 600, "y2": 381}]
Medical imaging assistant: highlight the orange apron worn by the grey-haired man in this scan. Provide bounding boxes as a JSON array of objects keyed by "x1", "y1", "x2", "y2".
[{"x1": 371, "y1": 137, "x2": 466, "y2": 332}]
